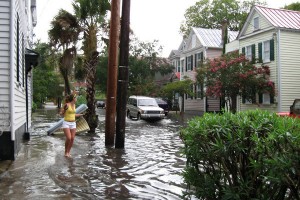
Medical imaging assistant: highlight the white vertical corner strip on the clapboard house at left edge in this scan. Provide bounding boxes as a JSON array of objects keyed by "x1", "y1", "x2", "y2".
[{"x1": 10, "y1": 0, "x2": 15, "y2": 141}]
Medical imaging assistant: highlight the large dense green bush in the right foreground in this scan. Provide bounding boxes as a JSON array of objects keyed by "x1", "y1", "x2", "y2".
[{"x1": 181, "y1": 110, "x2": 300, "y2": 199}]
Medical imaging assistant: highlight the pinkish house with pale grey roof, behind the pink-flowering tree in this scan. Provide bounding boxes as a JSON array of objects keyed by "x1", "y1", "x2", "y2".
[{"x1": 169, "y1": 27, "x2": 238, "y2": 114}]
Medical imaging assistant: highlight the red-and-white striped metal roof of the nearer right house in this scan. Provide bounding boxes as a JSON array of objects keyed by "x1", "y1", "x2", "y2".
[{"x1": 254, "y1": 6, "x2": 300, "y2": 30}]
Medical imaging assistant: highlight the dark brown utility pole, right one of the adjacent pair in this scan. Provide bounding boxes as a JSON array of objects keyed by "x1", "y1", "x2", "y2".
[{"x1": 115, "y1": 0, "x2": 130, "y2": 148}]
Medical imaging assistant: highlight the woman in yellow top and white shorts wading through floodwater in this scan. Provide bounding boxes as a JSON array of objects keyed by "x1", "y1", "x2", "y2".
[{"x1": 60, "y1": 94, "x2": 83, "y2": 157}]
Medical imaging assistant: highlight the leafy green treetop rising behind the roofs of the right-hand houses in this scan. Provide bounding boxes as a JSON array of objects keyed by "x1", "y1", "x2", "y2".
[{"x1": 180, "y1": 0, "x2": 266, "y2": 36}]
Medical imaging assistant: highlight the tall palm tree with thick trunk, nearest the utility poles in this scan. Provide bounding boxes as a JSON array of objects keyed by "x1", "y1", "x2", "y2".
[{"x1": 73, "y1": 0, "x2": 110, "y2": 132}]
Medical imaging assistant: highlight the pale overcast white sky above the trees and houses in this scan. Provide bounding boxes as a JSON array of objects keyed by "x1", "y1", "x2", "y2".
[{"x1": 34, "y1": 0, "x2": 300, "y2": 57}]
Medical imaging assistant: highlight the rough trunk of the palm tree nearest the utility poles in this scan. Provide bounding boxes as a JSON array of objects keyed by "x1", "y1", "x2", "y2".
[{"x1": 84, "y1": 51, "x2": 99, "y2": 133}]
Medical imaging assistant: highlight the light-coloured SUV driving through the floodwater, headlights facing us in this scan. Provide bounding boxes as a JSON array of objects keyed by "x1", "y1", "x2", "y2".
[{"x1": 127, "y1": 96, "x2": 165, "y2": 121}]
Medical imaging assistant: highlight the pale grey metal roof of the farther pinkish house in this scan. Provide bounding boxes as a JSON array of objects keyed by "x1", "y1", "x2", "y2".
[{"x1": 192, "y1": 27, "x2": 238, "y2": 47}]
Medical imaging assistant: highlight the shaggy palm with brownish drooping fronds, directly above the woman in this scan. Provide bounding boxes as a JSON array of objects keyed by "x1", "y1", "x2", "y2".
[{"x1": 48, "y1": 9, "x2": 81, "y2": 94}]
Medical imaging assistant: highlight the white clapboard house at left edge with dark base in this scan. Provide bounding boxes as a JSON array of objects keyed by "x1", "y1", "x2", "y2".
[{"x1": 0, "y1": 0, "x2": 38, "y2": 160}]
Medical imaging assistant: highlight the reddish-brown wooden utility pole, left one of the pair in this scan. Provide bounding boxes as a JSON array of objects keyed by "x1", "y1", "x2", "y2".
[{"x1": 105, "y1": 0, "x2": 120, "y2": 146}]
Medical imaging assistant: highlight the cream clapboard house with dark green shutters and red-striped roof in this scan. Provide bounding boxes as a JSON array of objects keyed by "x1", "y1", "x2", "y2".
[{"x1": 236, "y1": 6, "x2": 300, "y2": 112}]
